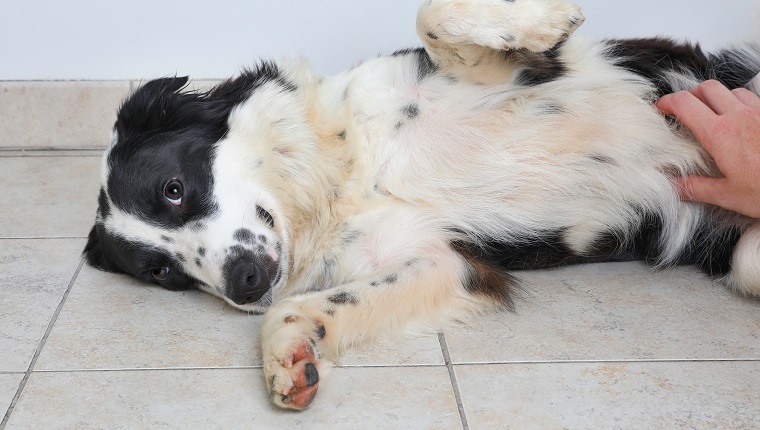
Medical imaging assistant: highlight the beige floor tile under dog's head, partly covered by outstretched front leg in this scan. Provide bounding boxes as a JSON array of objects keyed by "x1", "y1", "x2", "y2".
[{"x1": 36, "y1": 267, "x2": 443, "y2": 370}]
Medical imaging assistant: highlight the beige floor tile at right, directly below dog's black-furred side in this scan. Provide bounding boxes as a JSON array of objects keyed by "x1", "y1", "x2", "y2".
[{"x1": 446, "y1": 263, "x2": 760, "y2": 363}]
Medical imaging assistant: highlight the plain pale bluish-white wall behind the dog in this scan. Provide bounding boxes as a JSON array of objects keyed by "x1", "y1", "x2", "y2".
[{"x1": 0, "y1": 0, "x2": 757, "y2": 80}]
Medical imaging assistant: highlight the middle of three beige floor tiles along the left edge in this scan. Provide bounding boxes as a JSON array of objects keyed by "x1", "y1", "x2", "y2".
[{"x1": 0, "y1": 239, "x2": 84, "y2": 372}]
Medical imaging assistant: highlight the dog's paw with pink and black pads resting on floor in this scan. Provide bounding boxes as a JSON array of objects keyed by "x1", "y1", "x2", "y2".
[{"x1": 262, "y1": 315, "x2": 327, "y2": 410}]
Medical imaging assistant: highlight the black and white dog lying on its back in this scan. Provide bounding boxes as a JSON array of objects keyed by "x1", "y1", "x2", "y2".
[{"x1": 85, "y1": 0, "x2": 760, "y2": 409}]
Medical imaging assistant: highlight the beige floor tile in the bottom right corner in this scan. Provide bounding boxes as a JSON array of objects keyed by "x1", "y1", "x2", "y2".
[{"x1": 456, "y1": 362, "x2": 760, "y2": 430}]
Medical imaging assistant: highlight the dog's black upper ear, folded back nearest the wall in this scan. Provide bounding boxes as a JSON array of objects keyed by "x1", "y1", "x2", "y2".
[{"x1": 116, "y1": 76, "x2": 194, "y2": 136}]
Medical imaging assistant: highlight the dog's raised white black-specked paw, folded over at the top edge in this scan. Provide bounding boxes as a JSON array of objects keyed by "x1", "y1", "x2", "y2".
[{"x1": 418, "y1": 0, "x2": 585, "y2": 52}]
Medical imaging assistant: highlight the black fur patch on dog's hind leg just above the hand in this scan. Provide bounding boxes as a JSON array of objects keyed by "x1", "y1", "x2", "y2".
[{"x1": 603, "y1": 38, "x2": 760, "y2": 97}]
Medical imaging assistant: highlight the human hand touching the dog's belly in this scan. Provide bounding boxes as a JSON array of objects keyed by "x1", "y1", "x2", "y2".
[{"x1": 657, "y1": 81, "x2": 760, "y2": 218}]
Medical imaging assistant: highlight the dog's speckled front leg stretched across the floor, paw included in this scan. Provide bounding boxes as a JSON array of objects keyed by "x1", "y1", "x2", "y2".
[{"x1": 261, "y1": 249, "x2": 492, "y2": 409}]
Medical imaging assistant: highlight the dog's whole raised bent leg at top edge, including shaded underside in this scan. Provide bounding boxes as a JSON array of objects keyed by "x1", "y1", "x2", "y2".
[{"x1": 417, "y1": 0, "x2": 584, "y2": 83}]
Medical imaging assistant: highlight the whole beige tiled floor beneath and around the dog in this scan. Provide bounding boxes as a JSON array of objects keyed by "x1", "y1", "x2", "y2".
[{"x1": 0, "y1": 151, "x2": 760, "y2": 429}]
